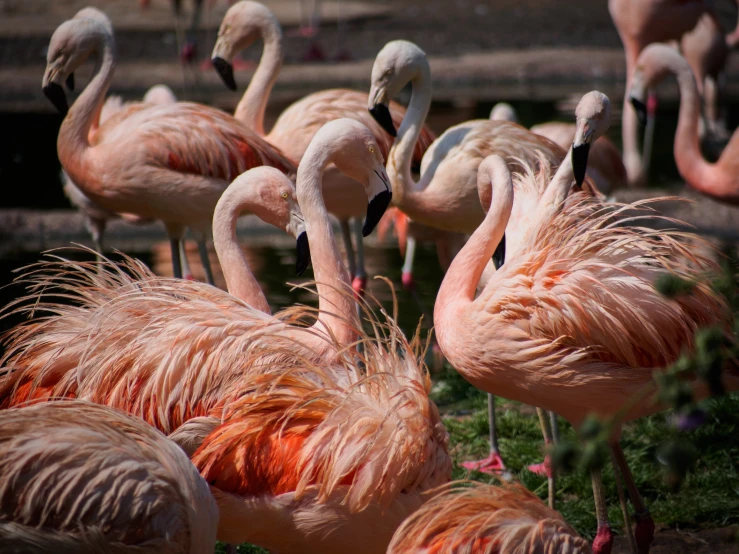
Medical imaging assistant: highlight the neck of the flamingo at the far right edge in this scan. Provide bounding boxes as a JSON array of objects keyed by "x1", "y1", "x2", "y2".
[{"x1": 668, "y1": 62, "x2": 711, "y2": 194}]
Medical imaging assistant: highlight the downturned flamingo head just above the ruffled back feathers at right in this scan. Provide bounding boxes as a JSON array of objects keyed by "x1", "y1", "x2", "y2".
[{"x1": 572, "y1": 90, "x2": 611, "y2": 187}]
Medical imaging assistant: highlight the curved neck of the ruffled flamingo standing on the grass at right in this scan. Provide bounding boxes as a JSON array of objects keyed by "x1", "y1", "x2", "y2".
[{"x1": 434, "y1": 177, "x2": 513, "y2": 314}]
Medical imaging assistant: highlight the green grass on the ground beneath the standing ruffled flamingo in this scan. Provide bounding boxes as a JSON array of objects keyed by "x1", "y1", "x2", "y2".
[{"x1": 433, "y1": 364, "x2": 739, "y2": 538}]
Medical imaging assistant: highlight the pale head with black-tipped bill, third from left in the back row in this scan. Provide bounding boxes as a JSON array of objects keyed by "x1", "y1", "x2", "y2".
[{"x1": 367, "y1": 40, "x2": 429, "y2": 136}]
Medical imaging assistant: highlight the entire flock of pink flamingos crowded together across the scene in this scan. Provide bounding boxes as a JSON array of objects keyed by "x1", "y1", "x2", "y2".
[{"x1": 0, "y1": 0, "x2": 739, "y2": 554}]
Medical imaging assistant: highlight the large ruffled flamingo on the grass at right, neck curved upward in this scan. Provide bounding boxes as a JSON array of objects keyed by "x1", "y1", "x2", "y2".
[{"x1": 434, "y1": 152, "x2": 739, "y2": 553}]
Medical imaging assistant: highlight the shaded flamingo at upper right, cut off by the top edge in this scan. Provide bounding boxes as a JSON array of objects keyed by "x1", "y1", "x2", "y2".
[{"x1": 608, "y1": 0, "x2": 706, "y2": 186}]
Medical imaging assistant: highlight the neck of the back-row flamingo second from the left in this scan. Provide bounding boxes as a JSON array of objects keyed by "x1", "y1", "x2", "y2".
[{"x1": 234, "y1": 20, "x2": 282, "y2": 136}]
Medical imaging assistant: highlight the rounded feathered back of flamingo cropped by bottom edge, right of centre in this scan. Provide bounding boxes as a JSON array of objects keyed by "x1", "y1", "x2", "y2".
[{"x1": 387, "y1": 483, "x2": 590, "y2": 554}]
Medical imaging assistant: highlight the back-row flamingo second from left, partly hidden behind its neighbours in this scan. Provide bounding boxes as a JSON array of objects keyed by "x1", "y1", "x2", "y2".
[{"x1": 212, "y1": 0, "x2": 435, "y2": 294}]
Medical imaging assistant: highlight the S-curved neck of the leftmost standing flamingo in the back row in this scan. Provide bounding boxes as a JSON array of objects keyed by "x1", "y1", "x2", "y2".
[{"x1": 57, "y1": 34, "x2": 115, "y2": 168}]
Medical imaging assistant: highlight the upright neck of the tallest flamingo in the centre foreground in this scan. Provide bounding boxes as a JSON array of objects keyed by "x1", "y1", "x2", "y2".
[{"x1": 297, "y1": 148, "x2": 359, "y2": 344}]
